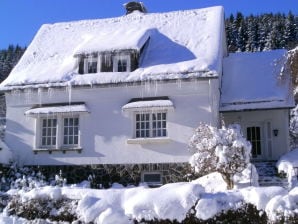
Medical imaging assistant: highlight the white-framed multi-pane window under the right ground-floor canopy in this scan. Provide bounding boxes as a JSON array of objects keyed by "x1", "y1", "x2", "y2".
[{"x1": 135, "y1": 112, "x2": 167, "y2": 138}]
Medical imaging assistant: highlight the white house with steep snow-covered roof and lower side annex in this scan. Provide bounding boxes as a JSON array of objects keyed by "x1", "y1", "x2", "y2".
[{"x1": 0, "y1": 3, "x2": 293, "y2": 186}]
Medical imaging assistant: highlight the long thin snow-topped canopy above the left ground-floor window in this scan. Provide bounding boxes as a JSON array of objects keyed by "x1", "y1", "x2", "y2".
[{"x1": 25, "y1": 104, "x2": 89, "y2": 116}]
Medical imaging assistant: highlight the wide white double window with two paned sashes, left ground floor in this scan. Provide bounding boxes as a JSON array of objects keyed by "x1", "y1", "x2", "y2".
[{"x1": 36, "y1": 115, "x2": 80, "y2": 149}]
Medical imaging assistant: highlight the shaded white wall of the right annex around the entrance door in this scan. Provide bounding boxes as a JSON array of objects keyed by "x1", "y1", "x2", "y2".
[{"x1": 223, "y1": 109, "x2": 289, "y2": 160}]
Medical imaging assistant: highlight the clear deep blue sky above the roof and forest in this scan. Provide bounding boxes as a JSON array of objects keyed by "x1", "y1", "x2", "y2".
[{"x1": 0, "y1": 0, "x2": 298, "y2": 49}]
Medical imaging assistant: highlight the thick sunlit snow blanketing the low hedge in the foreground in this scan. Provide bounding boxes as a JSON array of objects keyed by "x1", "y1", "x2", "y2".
[{"x1": 0, "y1": 167, "x2": 298, "y2": 224}]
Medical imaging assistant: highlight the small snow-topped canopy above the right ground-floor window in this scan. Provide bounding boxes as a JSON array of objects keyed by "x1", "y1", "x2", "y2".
[{"x1": 122, "y1": 97, "x2": 174, "y2": 112}]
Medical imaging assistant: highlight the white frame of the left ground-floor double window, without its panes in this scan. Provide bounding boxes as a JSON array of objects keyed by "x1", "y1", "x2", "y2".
[{"x1": 35, "y1": 114, "x2": 81, "y2": 150}]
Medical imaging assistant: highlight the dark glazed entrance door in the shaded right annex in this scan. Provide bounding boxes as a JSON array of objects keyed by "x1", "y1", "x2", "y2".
[{"x1": 246, "y1": 127, "x2": 262, "y2": 157}]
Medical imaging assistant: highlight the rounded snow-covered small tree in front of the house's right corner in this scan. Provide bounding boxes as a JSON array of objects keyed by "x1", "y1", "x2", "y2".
[{"x1": 189, "y1": 124, "x2": 251, "y2": 189}]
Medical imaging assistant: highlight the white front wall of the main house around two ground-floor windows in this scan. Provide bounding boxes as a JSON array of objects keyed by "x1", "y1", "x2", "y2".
[{"x1": 5, "y1": 79, "x2": 218, "y2": 165}]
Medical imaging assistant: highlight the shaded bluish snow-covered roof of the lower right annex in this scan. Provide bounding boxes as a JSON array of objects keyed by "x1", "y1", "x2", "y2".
[{"x1": 220, "y1": 50, "x2": 294, "y2": 112}]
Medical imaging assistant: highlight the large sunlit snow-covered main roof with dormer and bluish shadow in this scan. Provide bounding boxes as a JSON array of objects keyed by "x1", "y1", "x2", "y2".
[{"x1": 0, "y1": 6, "x2": 226, "y2": 90}]
